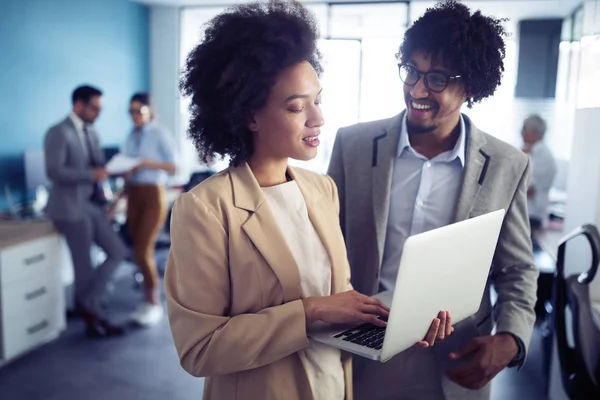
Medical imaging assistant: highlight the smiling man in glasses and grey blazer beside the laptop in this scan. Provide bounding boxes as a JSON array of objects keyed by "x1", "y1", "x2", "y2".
[{"x1": 328, "y1": 1, "x2": 537, "y2": 400}]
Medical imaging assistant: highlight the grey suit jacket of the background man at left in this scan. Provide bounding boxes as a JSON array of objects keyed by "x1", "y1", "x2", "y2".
[{"x1": 44, "y1": 117, "x2": 104, "y2": 221}]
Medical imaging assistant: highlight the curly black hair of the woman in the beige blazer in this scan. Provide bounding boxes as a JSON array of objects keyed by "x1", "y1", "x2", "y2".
[{"x1": 179, "y1": 0, "x2": 322, "y2": 166}]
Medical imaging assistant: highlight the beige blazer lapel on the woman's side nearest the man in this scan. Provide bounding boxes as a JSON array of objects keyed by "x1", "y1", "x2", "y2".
[{"x1": 288, "y1": 168, "x2": 347, "y2": 293}]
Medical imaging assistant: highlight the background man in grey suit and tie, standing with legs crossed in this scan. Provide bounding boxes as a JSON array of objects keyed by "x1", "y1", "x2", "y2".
[{"x1": 44, "y1": 86, "x2": 127, "y2": 337}]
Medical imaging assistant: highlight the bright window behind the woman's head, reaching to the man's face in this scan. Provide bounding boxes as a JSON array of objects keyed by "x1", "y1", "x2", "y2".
[{"x1": 180, "y1": 3, "x2": 407, "y2": 173}]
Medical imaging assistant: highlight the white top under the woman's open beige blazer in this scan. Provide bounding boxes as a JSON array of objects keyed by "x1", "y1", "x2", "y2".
[{"x1": 263, "y1": 181, "x2": 345, "y2": 400}]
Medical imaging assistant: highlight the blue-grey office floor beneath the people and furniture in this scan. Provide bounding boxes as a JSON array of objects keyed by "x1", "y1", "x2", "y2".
[{"x1": 0, "y1": 254, "x2": 546, "y2": 400}]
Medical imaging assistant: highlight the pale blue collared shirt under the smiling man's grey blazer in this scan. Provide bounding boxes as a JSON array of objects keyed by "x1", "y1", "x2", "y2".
[{"x1": 380, "y1": 116, "x2": 466, "y2": 290}]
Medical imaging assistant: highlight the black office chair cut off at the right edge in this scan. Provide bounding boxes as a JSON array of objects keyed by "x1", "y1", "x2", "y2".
[{"x1": 554, "y1": 225, "x2": 600, "y2": 400}]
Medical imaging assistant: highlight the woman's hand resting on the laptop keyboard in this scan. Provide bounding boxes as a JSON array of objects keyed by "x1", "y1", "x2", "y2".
[{"x1": 302, "y1": 290, "x2": 390, "y2": 327}]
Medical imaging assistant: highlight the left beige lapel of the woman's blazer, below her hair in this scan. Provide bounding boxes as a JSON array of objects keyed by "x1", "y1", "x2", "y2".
[{"x1": 229, "y1": 163, "x2": 301, "y2": 303}]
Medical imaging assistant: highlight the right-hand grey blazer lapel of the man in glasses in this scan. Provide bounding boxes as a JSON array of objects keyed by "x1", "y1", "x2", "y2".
[{"x1": 454, "y1": 115, "x2": 491, "y2": 222}]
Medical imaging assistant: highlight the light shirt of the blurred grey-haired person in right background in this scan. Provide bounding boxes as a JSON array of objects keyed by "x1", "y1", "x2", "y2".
[{"x1": 527, "y1": 140, "x2": 556, "y2": 223}]
